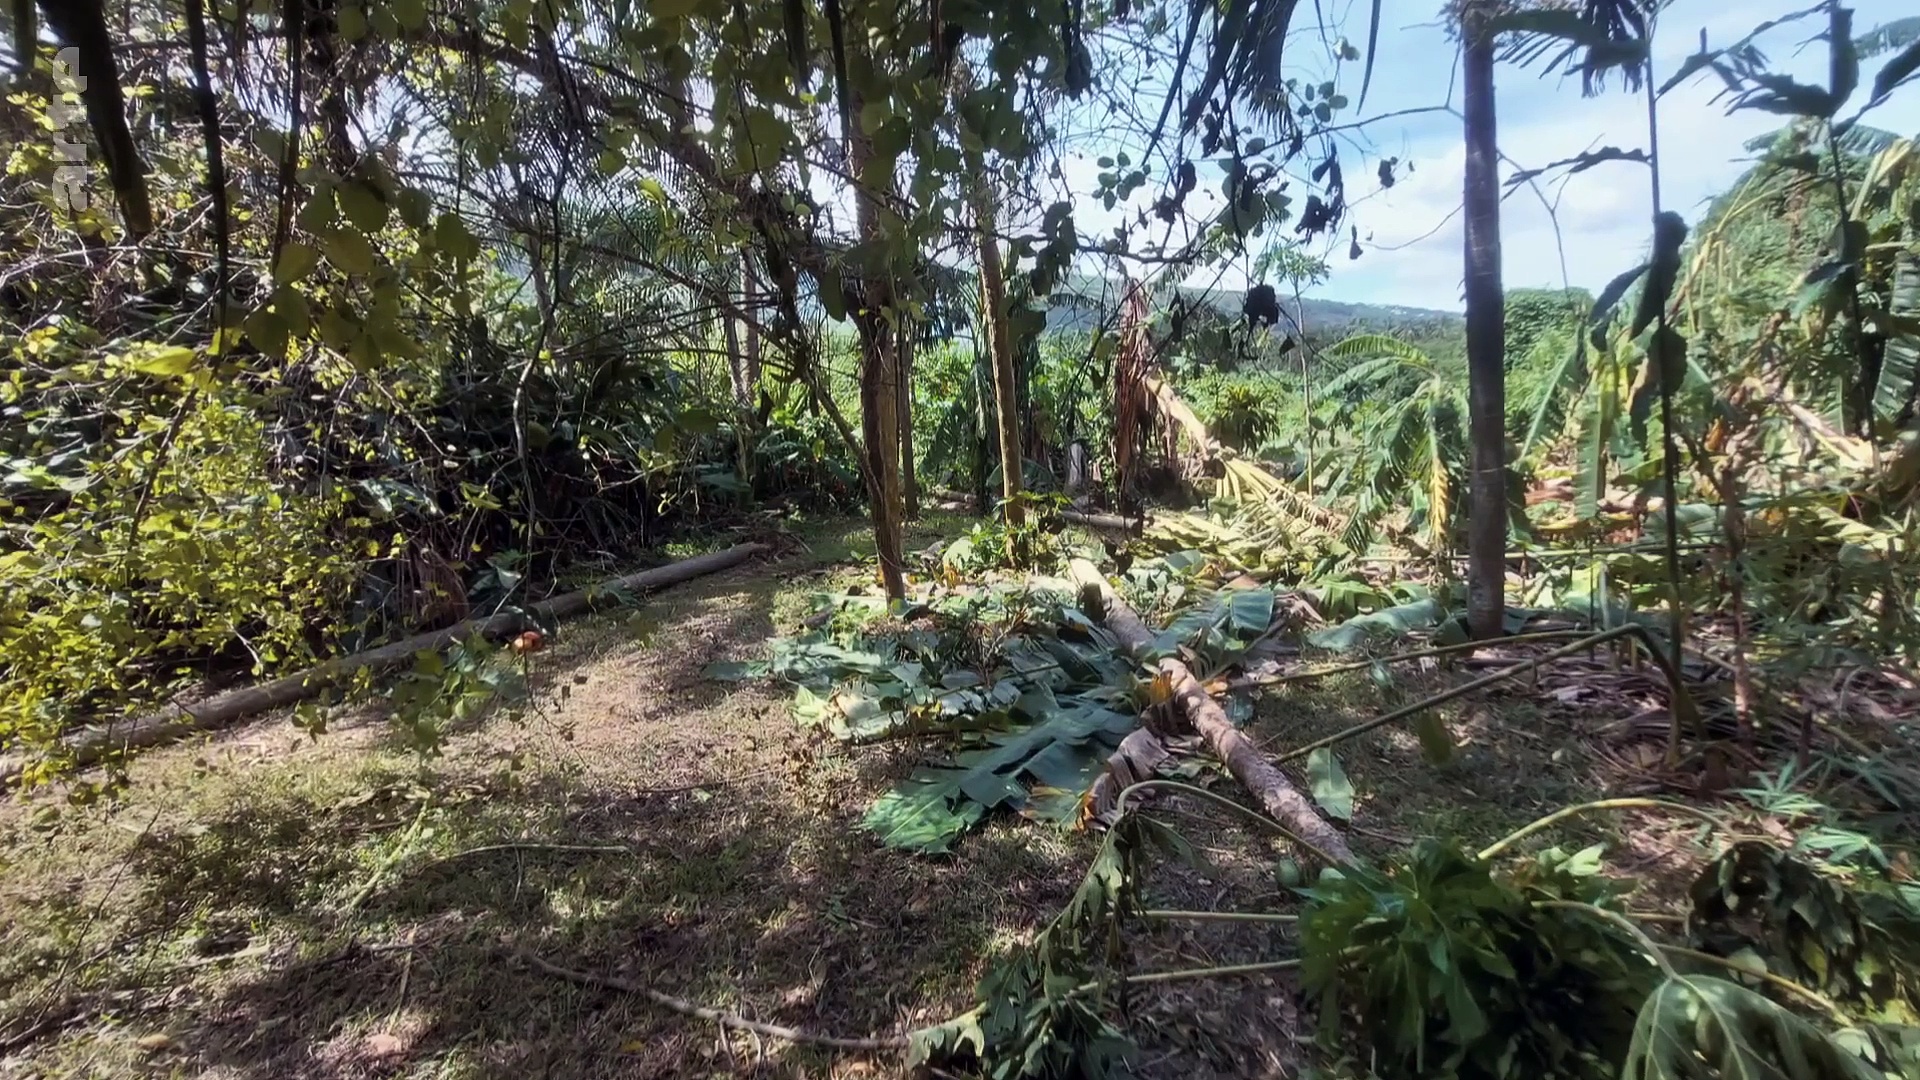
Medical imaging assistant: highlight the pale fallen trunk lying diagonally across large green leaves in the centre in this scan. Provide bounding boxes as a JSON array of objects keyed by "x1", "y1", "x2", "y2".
[{"x1": 1068, "y1": 559, "x2": 1354, "y2": 863}]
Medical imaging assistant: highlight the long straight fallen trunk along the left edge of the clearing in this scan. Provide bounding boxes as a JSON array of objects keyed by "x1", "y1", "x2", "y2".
[{"x1": 0, "y1": 544, "x2": 768, "y2": 786}]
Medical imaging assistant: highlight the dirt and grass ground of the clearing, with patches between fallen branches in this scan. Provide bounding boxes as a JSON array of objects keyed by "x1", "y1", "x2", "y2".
[{"x1": 0, "y1": 519, "x2": 1812, "y2": 1080}]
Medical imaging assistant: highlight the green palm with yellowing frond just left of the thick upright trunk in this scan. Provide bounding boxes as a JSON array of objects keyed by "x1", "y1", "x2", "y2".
[{"x1": 1321, "y1": 334, "x2": 1466, "y2": 555}]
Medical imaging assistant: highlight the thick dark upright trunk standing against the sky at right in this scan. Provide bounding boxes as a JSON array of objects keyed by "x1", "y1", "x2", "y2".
[{"x1": 1461, "y1": 16, "x2": 1507, "y2": 638}]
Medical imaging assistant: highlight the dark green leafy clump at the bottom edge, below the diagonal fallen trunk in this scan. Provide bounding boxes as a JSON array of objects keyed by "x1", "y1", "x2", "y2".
[{"x1": 1300, "y1": 840, "x2": 1655, "y2": 1078}]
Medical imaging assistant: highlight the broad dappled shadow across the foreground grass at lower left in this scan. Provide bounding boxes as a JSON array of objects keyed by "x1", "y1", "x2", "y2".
[{"x1": 118, "y1": 757, "x2": 1071, "y2": 1080}]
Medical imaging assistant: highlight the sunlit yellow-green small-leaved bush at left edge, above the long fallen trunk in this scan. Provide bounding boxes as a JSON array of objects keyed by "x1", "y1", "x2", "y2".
[{"x1": 0, "y1": 380, "x2": 357, "y2": 778}]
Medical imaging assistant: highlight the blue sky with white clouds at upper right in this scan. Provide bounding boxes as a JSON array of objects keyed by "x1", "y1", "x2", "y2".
[{"x1": 1315, "y1": 0, "x2": 1920, "y2": 309}]
